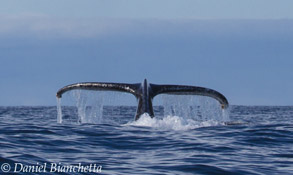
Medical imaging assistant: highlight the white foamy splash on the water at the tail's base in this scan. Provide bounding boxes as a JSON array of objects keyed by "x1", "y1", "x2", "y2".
[{"x1": 126, "y1": 113, "x2": 223, "y2": 130}]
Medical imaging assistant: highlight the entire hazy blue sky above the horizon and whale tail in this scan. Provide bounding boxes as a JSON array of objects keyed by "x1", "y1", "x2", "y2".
[{"x1": 0, "y1": 0, "x2": 293, "y2": 106}]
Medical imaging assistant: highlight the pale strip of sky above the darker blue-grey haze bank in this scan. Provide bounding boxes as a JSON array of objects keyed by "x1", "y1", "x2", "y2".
[{"x1": 0, "y1": 0, "x2": 293, "y2": 19}]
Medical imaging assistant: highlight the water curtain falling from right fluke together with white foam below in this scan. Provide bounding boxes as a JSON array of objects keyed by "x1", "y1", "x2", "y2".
[{"x1": 126, "y1": 95, "x2": 230, "y2": 130}]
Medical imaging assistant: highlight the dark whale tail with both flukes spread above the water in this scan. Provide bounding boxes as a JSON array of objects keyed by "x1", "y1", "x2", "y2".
[{"x1": 56, "y1": 79, "x2": 229, "y2": 120}]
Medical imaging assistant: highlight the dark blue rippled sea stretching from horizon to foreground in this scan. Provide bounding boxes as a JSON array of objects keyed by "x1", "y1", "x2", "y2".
[{"x1": 0, "y1": 106, "x2": 293, "y2": 175}]
